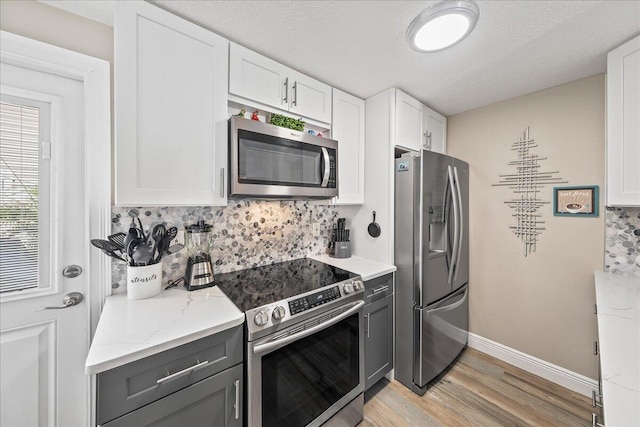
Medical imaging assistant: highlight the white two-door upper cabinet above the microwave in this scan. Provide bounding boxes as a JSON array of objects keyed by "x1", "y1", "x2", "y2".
[{"x1": 229, "y1": 43, "x2": 331, "y2": 124}]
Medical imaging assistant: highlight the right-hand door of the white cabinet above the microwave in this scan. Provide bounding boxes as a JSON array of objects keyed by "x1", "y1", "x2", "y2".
[{"x1": 289, "y1": 70, "x2": 331, "y2": 123}]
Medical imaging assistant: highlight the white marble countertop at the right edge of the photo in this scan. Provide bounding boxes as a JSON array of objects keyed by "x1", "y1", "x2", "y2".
[{"x1": 595, "y1": 271, "x2": 640, "y2": 427}]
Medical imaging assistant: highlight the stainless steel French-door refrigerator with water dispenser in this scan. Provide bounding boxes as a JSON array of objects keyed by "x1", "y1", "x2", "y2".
[{"x1": 395, "y1": 151, "x2": 469, "y2": 395}]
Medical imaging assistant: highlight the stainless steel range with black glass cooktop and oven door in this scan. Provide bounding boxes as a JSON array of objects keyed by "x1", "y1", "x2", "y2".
[{"x1": 215, "y1": 258, "x2": 364, "y2": 427}]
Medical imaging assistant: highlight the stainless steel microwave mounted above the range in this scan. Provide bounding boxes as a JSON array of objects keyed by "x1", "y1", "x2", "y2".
[{"x1": 228, "y1": 116, "x2": 338, "y2": 199}]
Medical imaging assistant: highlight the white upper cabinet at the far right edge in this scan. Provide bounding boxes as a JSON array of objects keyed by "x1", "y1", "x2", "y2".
[{"x1": 607, "y1": 36, "x2": 640, "y2": 206}]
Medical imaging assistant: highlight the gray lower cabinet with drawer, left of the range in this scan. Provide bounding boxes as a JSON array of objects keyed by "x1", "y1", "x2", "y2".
[{"x1": 96, "y1": 326, "x2": 243, "y2": 427}]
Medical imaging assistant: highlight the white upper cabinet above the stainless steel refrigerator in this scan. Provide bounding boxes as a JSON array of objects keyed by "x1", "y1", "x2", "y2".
[{"x1": 395, "y1": 89, "x2": 447, "y2": 154}]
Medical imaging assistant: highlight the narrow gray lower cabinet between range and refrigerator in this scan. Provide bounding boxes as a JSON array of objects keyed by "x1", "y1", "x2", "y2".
[{"x1": 364, "y1": 274, "x2": 393, "y2": 390}]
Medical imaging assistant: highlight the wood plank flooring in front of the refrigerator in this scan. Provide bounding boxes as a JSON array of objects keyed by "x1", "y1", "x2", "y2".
[{"x1": 359, "y1": 348, "x2": 601, "y2": 427}]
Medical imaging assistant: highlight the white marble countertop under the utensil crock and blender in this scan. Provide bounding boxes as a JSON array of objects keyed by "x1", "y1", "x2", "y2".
[{"x1": 85, "y1": 287, "x2": 244, "y2": 375}]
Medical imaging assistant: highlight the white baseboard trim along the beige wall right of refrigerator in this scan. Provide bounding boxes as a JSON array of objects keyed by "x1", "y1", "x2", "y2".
[{"x1": 468, "y1": 332, "x2": 598, "y2": 397}]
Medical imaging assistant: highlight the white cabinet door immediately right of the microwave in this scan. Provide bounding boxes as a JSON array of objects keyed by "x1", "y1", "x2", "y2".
[{"x1": 331, "y1": 89, "x2": 365, "y2": 205}]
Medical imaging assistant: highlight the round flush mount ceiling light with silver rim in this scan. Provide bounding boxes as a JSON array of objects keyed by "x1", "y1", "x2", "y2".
[{"x1": 407, "y1": 0, "x2": 480, "y2": 52}]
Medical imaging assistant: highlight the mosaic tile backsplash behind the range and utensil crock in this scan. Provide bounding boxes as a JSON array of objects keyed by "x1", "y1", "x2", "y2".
[{"x1": 111, "y1": 200, "x2": 338, "y2": 293}]
